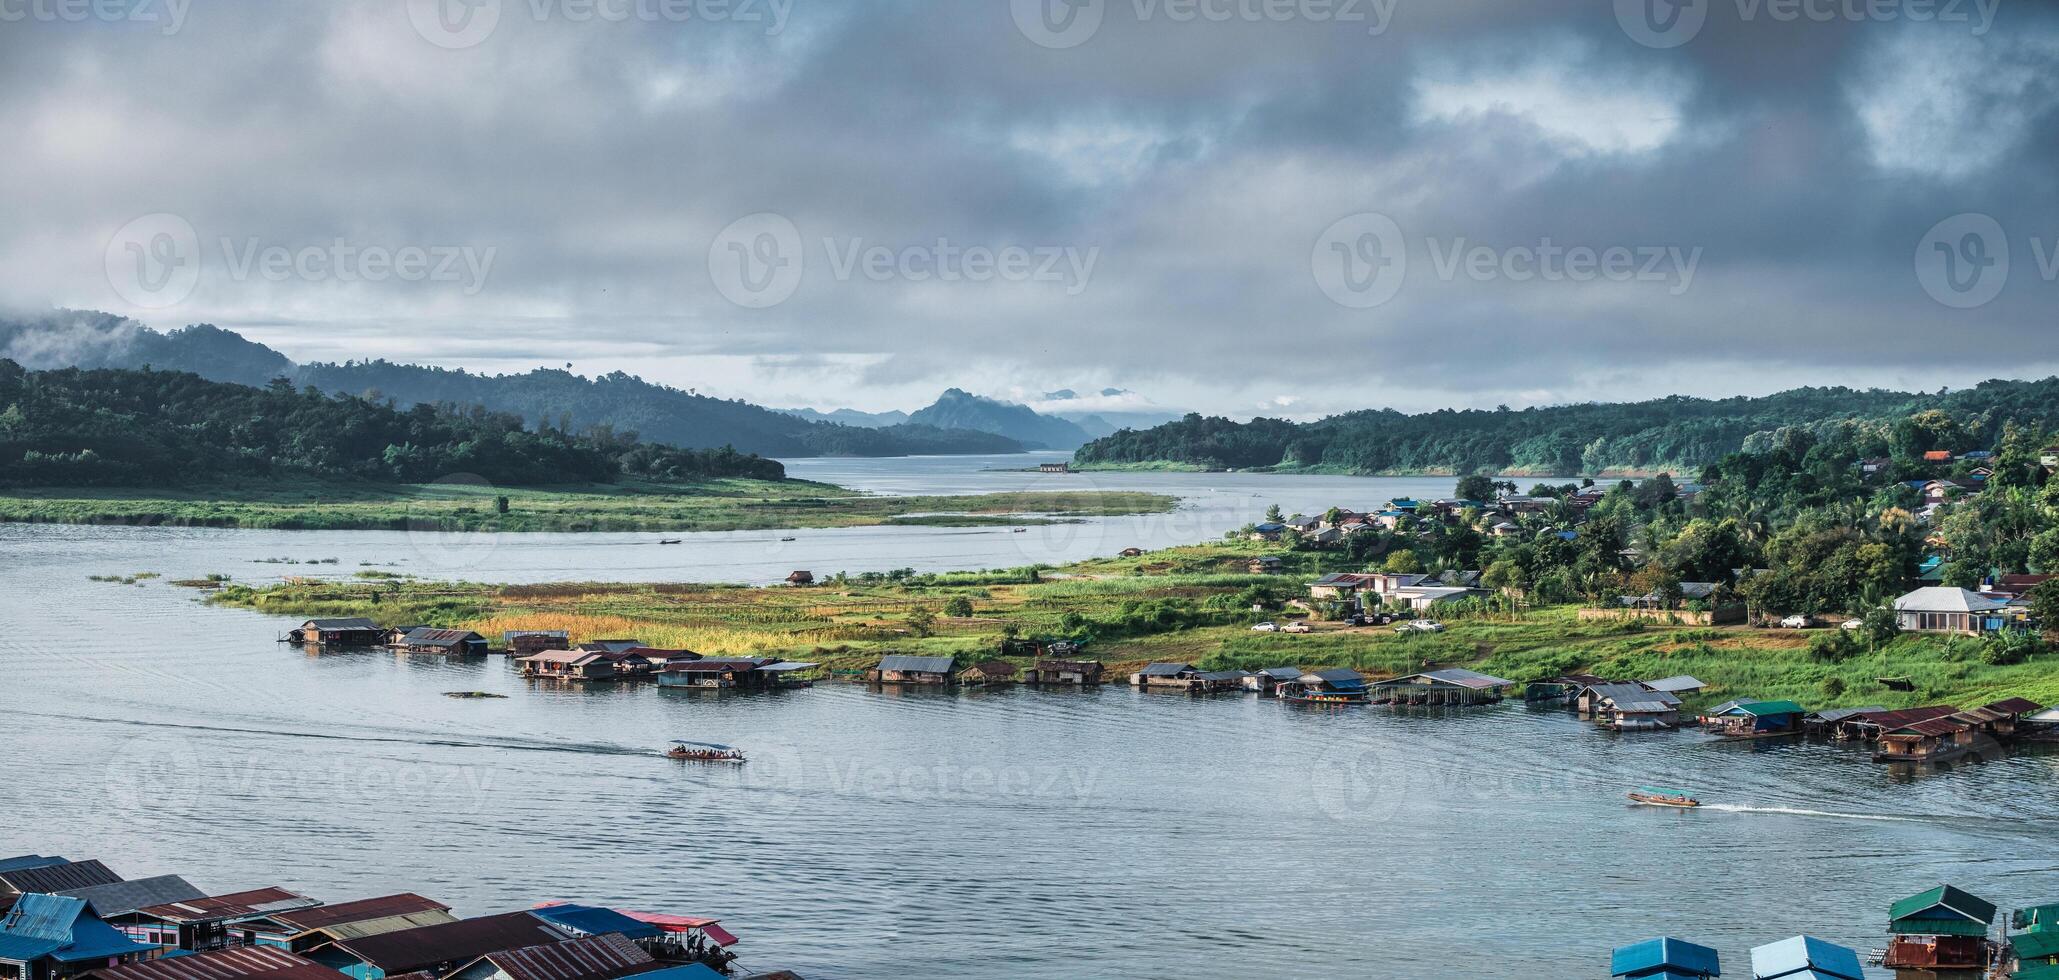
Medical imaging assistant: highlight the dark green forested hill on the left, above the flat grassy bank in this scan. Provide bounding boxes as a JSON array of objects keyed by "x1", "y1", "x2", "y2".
[{"x1": 0, "y1": 360, "x2": 787, "y2": 486}]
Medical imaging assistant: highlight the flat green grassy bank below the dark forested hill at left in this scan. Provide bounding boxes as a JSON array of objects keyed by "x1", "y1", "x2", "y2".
[{"x1": 0, "y1": 480, "x2": 1176, "y2": 531}]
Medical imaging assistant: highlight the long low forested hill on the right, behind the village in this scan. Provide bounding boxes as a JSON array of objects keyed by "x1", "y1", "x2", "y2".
[{"x1": 1075, "y1": 379, "x2": 2059, "y2": 476}]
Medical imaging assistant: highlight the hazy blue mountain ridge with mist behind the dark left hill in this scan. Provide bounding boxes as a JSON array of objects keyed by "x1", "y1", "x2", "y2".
[{"x1": 0, "y1": 311, "x2": 1021, "y2": 457}]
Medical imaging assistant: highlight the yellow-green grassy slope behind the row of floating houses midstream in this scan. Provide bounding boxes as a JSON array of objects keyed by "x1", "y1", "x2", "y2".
[{"x1": 208, "y1": 541, "x2": 2059, "y2": 708}]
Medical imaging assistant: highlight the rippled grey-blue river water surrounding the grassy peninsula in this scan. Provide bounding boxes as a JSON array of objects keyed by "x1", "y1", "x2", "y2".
[{"x1": 0, "y1": 457, "x2": 2059, "y2": 978}]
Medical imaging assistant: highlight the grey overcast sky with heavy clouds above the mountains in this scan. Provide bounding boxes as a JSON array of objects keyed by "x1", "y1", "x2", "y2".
[{"x1": 0, "y1": 0, "x2": 2059, "y2": 418}]
